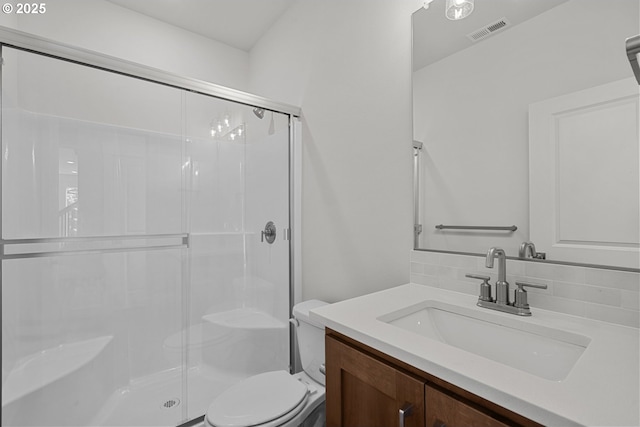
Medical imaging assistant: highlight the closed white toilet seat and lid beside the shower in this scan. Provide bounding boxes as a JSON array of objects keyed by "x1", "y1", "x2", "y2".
[{"x1": 206, "y1": 371, "x2": 309, "y2": 427}]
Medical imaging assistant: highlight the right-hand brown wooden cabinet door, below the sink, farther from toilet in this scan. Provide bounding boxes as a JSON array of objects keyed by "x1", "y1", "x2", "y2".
[{"x1": 425, "y1": 385, "x2": 509, "y2": 427}]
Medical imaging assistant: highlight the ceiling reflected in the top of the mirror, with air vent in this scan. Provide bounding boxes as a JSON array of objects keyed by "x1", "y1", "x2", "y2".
[{"x1": 413, "y1": 0, "x2": 567, "y2": 71}]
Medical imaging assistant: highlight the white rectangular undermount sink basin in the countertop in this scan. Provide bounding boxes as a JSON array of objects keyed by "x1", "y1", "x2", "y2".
[{"x1": 378, "y1": 300, "x2": 591, "y2": 381}]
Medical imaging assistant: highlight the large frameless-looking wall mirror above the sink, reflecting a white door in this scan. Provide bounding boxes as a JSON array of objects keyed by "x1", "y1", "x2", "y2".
[{"x1": 412, "y1": 0, "x2": 640, "y2": 269}]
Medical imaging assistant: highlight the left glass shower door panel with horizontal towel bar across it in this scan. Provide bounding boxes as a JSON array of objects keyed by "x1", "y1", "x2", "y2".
[{"x1": 2, "y1": 47, "x2": 187, "y2": 426}]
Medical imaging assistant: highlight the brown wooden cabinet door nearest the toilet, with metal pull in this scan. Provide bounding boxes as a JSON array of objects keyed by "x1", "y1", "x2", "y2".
[{"x1": 325, "y1": 336, "x2": 425, "y2": 427}]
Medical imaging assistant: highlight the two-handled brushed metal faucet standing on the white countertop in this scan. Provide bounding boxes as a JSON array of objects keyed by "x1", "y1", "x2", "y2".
[{"x1": 466, "y1": 247, "x2": 547, "y2": 316}]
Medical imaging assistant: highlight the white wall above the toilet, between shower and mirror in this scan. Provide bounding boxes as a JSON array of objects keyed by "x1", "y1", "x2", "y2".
[{"x1": 250, "y1": 0, "x2": 421, "y2": 302}]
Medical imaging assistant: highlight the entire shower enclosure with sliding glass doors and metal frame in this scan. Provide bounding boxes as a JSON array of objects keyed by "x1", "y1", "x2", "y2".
[{"x1": 0, "y1": 30, "x2": 297, "y2": 426}]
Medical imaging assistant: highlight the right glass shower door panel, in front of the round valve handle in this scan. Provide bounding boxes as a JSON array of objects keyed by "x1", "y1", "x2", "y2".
[{"x1": 180, "y1": 93, "x2": 290, "y2": 418}]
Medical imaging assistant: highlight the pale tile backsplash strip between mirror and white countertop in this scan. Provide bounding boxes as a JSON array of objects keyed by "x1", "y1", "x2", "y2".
[{"x1": 411, "y1": 250, "x2": 640, "y2": 328}]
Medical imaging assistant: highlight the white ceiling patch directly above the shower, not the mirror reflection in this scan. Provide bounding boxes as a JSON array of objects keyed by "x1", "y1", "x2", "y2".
[{"x1": 107, "y1": 0, "x2": 295, "y2": 51}]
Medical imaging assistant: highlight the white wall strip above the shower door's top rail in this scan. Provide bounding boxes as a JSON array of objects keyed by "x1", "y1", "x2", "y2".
[{"x1": 0, "y1": 0, "x2": 249, "y2": 91}]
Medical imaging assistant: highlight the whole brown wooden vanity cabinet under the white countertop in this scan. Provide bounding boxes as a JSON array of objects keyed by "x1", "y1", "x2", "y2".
[{"x1": 325, "y1": 329, "x2": 540, "y2": 427}]
